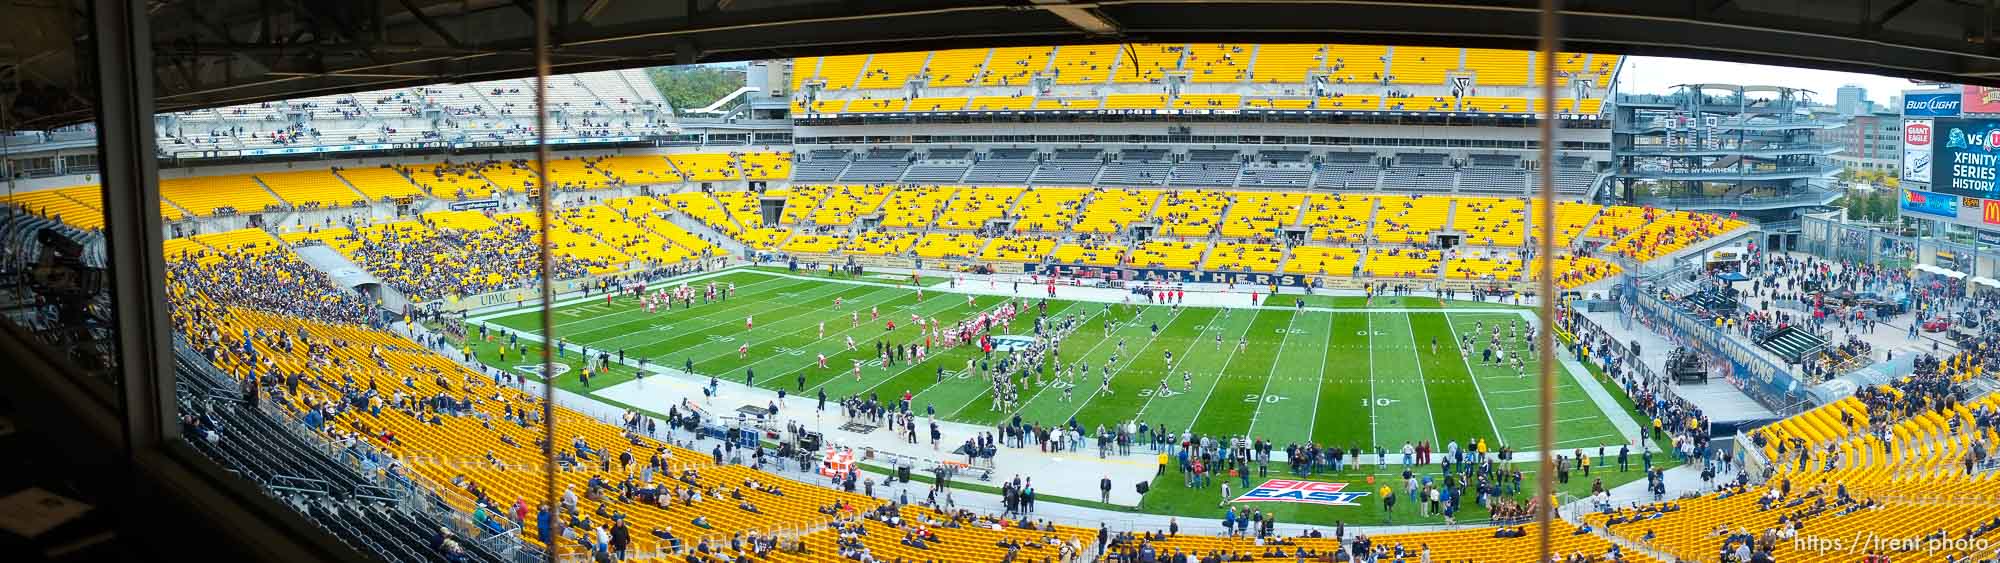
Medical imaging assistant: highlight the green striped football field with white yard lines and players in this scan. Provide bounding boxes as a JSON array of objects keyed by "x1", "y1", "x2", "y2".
[{"x1": 470, "y1": 270, "x2": 1626, "y2": 451}]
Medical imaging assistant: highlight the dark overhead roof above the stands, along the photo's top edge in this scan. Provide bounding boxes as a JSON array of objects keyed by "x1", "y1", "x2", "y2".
[{"x1": 15, "y1": 0, "x2": 2000, "y2": 128}]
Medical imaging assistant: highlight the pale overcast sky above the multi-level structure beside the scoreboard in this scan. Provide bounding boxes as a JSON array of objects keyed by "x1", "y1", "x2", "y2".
[{"x1": 1618, "y1": 56, "x2": 1918, "y2": 104}]
